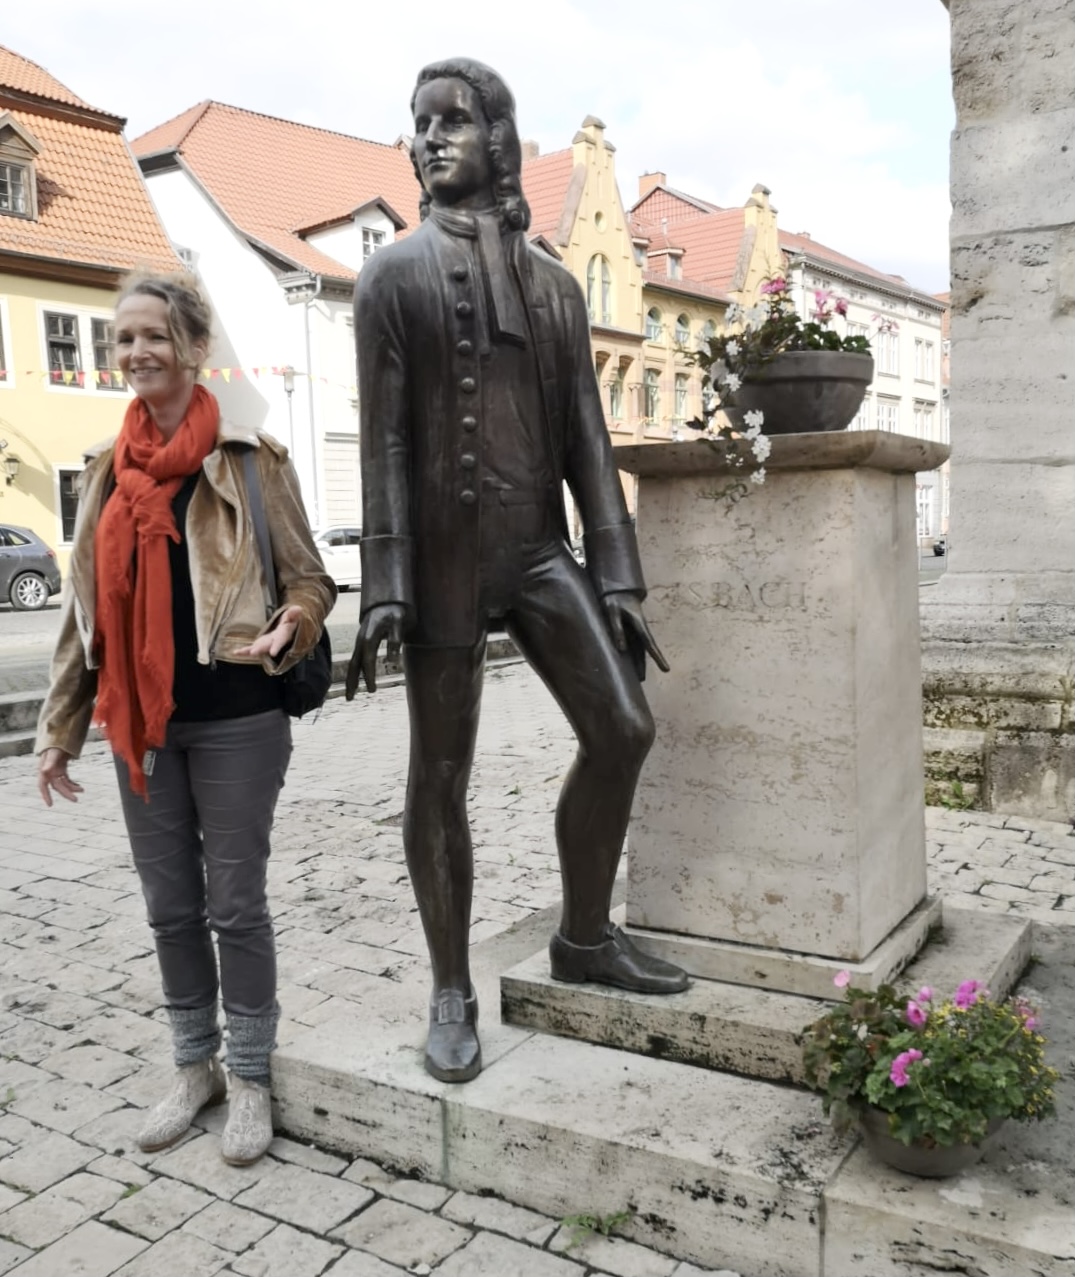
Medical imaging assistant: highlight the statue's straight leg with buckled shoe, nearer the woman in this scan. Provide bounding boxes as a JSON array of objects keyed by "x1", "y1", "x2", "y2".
[{"x1": 403, "y1": 639, "x2": 485, "y2": 1082}]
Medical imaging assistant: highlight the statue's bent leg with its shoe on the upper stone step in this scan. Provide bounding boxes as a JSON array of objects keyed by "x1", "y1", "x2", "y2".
[{"x1": 507, "y1": 547, "x2": 687, "y2": 992}]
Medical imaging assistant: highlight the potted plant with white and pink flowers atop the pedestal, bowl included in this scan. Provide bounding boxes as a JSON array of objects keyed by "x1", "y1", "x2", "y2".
[{"x1": 695, "y1": 277, "x2": 873, "y2": 434}]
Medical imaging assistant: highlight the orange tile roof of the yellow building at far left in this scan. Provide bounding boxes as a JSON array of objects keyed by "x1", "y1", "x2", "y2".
[{"x1": 0, "y1": 49, "x2": 179, "y2": 271}]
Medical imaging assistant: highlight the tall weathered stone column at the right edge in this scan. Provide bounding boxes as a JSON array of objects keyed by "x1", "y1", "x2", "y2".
[{"x1": 922, "y1": 0, "x2": 1075, "y2": 820}]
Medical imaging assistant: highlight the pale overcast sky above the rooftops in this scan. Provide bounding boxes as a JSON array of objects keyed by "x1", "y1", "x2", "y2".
[{"x1": 0, "y1": 0, "x2": 954, "y2": 292}]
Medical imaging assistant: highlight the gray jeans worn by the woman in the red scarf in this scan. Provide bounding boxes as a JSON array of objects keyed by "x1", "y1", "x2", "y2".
[{"x1": 116, "y1": 710, "x2": 291, "y2": 1018}]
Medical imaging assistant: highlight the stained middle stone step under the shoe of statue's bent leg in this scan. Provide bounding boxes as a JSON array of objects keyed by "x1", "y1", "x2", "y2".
[{"x1": 500, "y1": 907, "x2": 1032, "y2": 1083}]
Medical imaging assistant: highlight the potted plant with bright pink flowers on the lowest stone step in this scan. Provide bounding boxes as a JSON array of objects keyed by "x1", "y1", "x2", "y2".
[{"x1": 803, "y1": 972, "x2": 1058, "y2": 1176}]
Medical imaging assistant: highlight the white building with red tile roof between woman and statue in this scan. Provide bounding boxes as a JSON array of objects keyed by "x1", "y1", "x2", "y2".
[{"x1": 132, "y1": 102, "x2": 419, "y2": 527}]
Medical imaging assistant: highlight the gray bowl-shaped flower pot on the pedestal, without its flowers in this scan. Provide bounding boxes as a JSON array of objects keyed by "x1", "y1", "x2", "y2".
[{"x1": 728, "y1": 350, "x2": 873, "y2": 434}]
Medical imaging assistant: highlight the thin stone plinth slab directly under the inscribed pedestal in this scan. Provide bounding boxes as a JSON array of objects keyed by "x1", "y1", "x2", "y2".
[{"x1": 627, "y1": 896, "x2": 943, "y2": 997}]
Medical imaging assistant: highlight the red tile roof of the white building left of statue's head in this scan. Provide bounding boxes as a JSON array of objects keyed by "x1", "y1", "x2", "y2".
[{"x1": 132, "y1": 102, "x2": 419, "y2": 280}]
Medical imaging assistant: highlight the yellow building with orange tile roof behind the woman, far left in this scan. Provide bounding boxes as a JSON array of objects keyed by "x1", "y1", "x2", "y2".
[{"x1": 0, "y1": 47, "x2": 180, "y2": 570}]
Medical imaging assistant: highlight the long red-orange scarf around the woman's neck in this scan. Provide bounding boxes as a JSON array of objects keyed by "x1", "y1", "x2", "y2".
[{"x1": 93, "y1": 386, "x2": 220, "y2": 797}]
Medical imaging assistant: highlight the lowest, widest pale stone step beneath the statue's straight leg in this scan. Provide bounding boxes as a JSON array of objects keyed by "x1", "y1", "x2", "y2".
[{"x1": 273, "y1": 911, "x2": 1075, "y2": 1277}]
